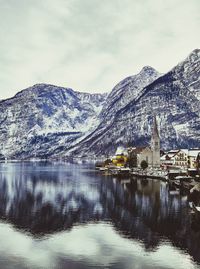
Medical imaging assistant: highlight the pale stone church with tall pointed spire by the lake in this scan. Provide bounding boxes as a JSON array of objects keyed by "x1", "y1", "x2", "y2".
[{"x1": 136, "y1": 116, "x2": 160, "y2": 167}]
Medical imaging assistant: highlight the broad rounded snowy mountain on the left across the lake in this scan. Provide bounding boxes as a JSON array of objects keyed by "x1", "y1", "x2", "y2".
[{"x1": 0, "y1": 84, "x2": 106, "y2": 158}]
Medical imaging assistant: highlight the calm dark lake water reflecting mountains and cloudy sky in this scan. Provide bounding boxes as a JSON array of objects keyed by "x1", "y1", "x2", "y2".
[{"x1": 0, "y1": 162, "x2": 200, "y2": 269}]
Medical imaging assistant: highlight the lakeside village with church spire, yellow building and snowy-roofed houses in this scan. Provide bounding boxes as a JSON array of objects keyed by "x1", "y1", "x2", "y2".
[{"x1": 96, "y1": 116, "x2": 200, "y2": 219}]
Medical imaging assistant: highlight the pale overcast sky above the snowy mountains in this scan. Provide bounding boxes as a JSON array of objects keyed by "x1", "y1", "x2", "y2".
[{"x1": 0, "y1": 0, "x2": 200, "y2": 99}]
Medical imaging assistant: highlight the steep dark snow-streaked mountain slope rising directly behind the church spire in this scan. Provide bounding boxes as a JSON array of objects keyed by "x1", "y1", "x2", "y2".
[{"x1": 68, "y1": 50, "x2": 200, "y2": 155}]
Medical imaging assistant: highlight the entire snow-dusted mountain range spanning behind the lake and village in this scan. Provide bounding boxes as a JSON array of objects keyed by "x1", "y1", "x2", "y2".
[{"x1": 0, "y1": 49, "x2": 200, "y2": 158}]
